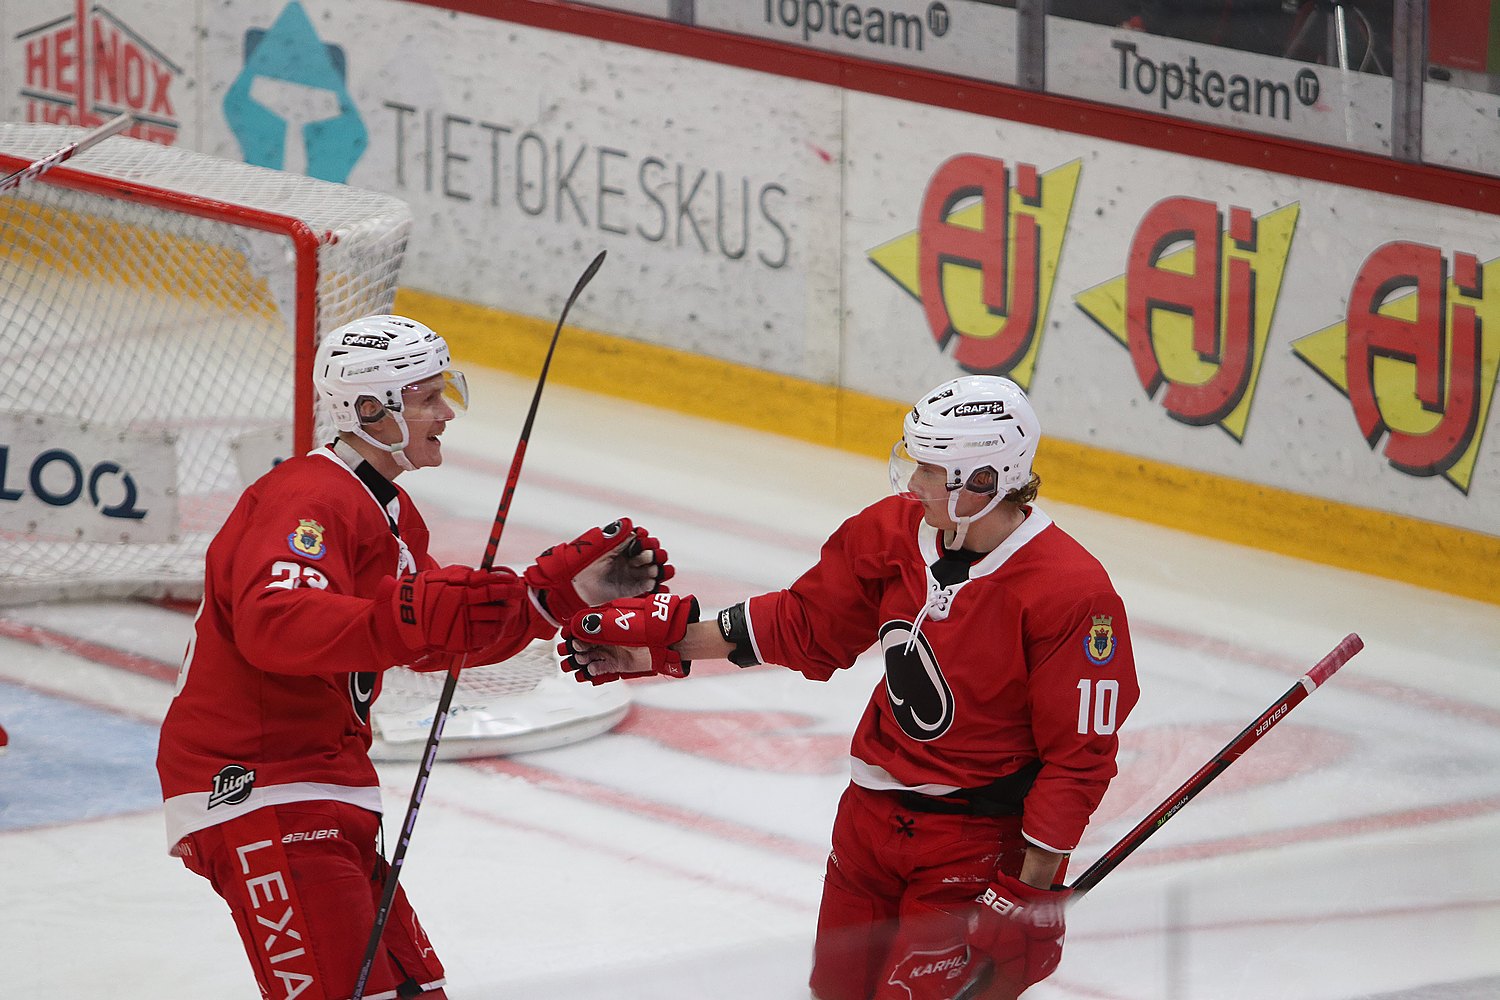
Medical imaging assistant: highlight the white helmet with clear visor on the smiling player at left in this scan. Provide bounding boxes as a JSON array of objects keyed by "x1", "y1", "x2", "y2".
[{"x1": 312, "y1": 315, "x2": 468, "y2": 468}]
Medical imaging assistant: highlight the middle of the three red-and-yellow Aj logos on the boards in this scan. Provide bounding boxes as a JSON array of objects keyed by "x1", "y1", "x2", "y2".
[{"x1": 1074, "y1": 198, "x2": 1298, "y2": 441}]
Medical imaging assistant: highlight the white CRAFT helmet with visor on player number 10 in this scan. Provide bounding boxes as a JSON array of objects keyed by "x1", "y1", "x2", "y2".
[{"x1": 890, "y1": 375, "x2": 1041, "y2": 546}]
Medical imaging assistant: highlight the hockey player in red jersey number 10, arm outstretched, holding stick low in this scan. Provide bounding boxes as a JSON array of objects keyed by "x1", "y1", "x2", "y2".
[{"x1": 560, "y1": 375, "x2": 1139, "y2": 1000}]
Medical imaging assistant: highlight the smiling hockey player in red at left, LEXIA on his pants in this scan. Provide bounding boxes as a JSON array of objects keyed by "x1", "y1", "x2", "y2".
[{"x1": 156, "y1": 316, "x2": 671, "y2": 1000}]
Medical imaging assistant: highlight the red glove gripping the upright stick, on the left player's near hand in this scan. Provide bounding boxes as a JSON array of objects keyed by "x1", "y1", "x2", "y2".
[{"x1": 390, "y1": 565, "x2": 527, "y2": 652}]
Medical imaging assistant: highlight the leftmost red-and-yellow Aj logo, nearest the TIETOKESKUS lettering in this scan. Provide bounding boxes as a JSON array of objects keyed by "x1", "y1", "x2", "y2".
[{"x1": 869, "y1": 154, "x2": 1082, "y2": 388}]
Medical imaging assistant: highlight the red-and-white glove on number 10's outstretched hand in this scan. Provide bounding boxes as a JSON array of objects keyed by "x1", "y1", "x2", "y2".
[{"x1": 558, "y1": 594, "x2": 698, "y2": 684}]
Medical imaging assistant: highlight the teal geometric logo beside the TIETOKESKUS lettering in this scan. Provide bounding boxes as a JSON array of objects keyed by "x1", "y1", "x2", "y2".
[{"x1": 224, "y1": 0, "x2": 369, "y2": 183}]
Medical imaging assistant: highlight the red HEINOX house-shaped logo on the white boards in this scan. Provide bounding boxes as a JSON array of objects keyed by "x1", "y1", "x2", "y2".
[{"x1": 8, "y1": 0, "x2": 182, "y2": 145}]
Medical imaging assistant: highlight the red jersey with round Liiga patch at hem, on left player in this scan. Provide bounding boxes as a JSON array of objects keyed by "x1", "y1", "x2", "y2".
[{"x1": 156, "y1": 448, "x2": 555, "y2": 846}]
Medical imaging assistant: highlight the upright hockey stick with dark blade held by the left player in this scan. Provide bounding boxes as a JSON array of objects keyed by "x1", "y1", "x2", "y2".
[{"x1": 351, "y1": 250, "x2": 605, "y2": 1000}]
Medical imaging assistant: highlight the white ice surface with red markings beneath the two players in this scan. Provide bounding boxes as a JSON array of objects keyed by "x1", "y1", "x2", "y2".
[{"x1": 0, "y1": 372, "x2": 1500, "y2": 1000}]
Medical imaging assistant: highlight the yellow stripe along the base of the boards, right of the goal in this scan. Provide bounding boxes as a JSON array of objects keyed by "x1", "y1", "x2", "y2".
[{"x1": 396, "y1": 289, "x2": 1500, "y2": 604}]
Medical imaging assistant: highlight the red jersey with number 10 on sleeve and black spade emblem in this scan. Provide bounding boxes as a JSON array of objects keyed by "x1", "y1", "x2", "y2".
[{"x1": 746, "y1": 496, "x2": 1140, "y2": 853}]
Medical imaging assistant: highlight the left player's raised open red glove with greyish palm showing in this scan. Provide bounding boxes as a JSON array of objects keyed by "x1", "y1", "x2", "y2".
[{"x1": 525, "y1": 517, "x2": 675, "y2": 625}]
